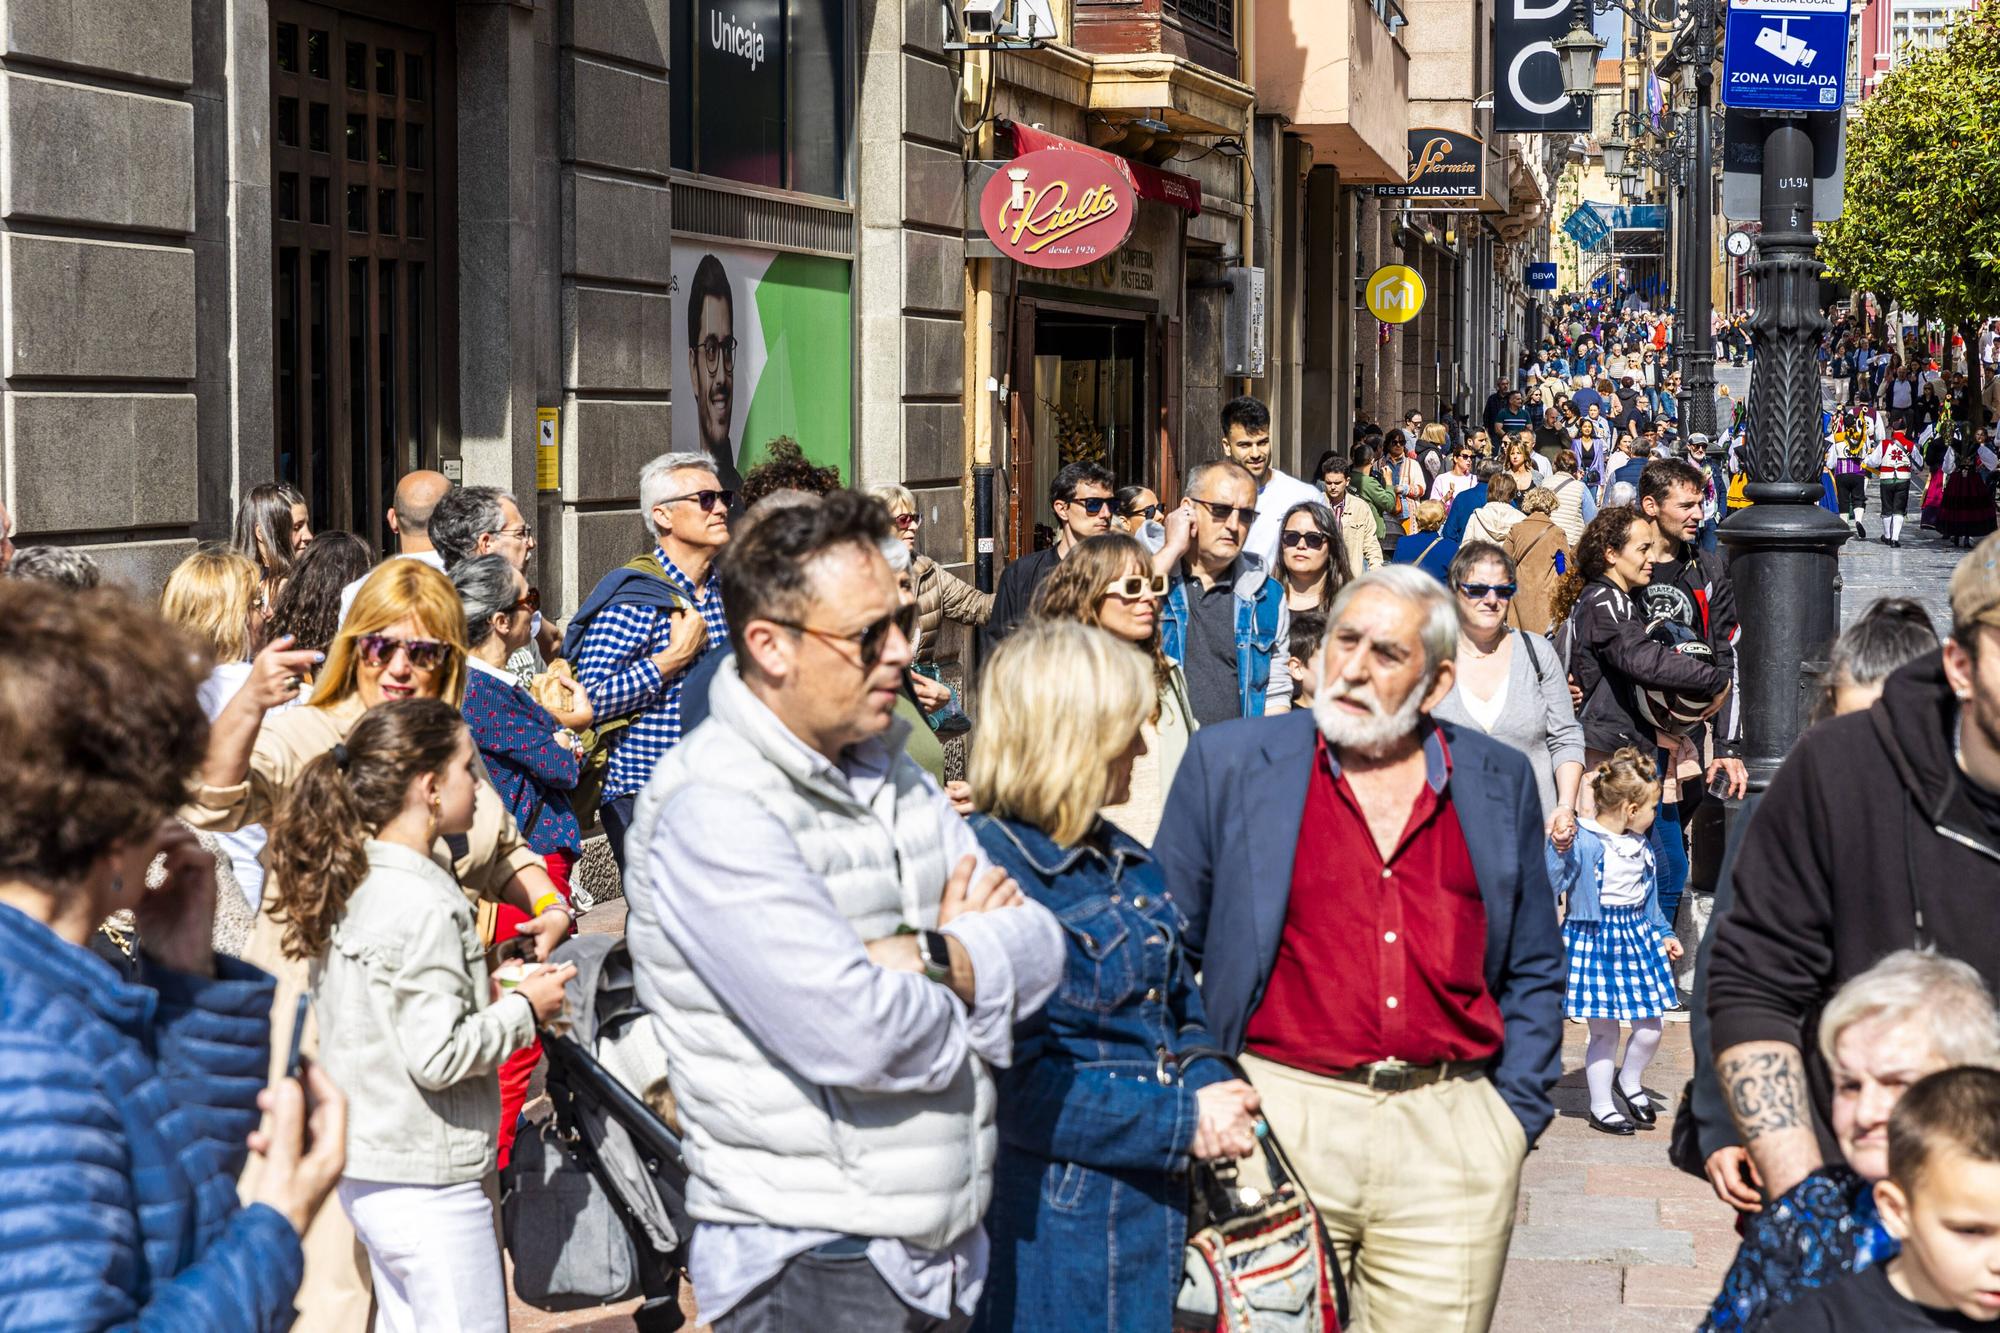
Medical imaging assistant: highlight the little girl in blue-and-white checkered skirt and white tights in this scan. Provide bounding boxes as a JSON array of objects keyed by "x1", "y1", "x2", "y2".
[{"x1": 1548, "y1": 747, "x2": 1680, "y2": 1135}]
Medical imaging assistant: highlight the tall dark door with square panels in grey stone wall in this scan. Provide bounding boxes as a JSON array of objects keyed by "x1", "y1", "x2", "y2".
[{"x1": 256, "y1": 0, "x2": 456, "y2": 548}]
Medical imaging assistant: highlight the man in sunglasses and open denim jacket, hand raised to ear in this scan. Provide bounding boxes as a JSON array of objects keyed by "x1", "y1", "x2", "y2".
[{"x1": 1154, "y1": 458, "x2": 1292, "y2": 725}]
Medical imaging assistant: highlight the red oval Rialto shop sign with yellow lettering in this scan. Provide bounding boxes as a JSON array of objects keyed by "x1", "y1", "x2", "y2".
[{"x1": 980, "y1": 148, "x2": 1138, "y2": 268}]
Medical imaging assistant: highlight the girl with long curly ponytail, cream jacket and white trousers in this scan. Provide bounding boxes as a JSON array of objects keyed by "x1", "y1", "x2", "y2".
[{"x1": 266, "y1": 699, "x2": 576, "y2": 1333}]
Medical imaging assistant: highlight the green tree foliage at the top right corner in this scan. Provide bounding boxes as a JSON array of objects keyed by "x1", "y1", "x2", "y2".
[{"x1": 1820, "y1": 6, "x2": 2000, "y2": 324}]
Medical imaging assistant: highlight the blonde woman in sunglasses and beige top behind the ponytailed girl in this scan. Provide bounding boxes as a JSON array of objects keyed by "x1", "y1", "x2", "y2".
[{"x1": 182, "y1": 560, "x2": 572, "y2": 1327}]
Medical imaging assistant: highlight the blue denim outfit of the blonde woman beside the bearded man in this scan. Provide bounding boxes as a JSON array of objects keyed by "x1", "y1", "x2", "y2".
[{"x1": 972, "y1": 815, "x2": 1232, "y2": 1333}]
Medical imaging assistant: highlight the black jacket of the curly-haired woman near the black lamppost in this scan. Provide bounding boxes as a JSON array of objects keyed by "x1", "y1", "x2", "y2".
[{"x1": 1558, "y1": 578, "x2": 1728, "y2": 755}]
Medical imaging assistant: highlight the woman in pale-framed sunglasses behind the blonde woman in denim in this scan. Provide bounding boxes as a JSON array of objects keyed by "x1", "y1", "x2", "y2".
[{"x1": 1032, "y1": 532, "x2": 1198, "y2": 847}]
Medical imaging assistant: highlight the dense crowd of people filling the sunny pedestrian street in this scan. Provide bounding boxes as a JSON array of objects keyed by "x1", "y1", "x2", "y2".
[{"x1": 0, "y1": 344, "x2": 2000, "y2": 1333}]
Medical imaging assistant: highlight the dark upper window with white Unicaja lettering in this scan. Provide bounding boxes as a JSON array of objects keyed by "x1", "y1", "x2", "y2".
[{"x1": 672, "y1": 0, "x2": 844, "y2": 198}]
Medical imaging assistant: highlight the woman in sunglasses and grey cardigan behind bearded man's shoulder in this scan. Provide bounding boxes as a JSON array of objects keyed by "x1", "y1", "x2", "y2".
[{"x1": 1434, "y1": 542, "x2": 1584, "y2": 851}]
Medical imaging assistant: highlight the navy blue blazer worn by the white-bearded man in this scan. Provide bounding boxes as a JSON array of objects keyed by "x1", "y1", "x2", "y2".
[{"x1": 1152, "y1": 713, "x2": 1568, "y2": 1143}]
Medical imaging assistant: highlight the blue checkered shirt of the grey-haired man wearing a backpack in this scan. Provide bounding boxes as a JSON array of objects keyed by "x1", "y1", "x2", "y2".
[{"x1": 576, "y1": 548, "x2": 730, "y2": 805}]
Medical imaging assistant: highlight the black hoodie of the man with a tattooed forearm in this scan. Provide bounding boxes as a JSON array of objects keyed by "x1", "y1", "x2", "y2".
[{"x1": 1708, "y1": 652, "x2": 2000, "y2": 1153}]
